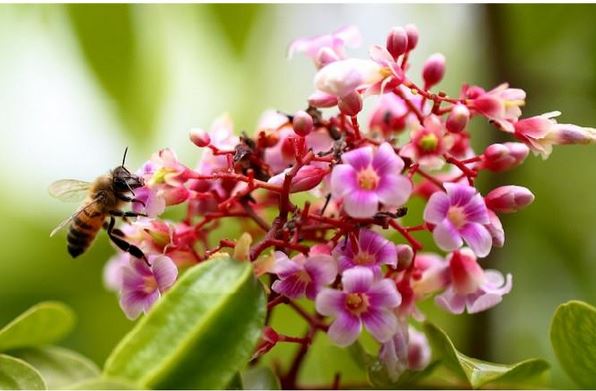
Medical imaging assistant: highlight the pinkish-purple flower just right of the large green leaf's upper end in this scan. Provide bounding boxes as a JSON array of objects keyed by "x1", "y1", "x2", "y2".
[{"x1": 271, "y1": 251, "x2": 337, "y2": 300}]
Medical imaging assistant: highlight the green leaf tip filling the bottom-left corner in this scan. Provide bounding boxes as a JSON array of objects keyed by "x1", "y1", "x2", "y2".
[{"x1": 0, "y1": 354, "x2": 47, "y2": 390}]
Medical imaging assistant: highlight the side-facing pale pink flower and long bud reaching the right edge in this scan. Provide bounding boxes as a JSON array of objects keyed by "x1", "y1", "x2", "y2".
[{"x1": 515, "y1": 111, "x2": 596, "y2": 159}]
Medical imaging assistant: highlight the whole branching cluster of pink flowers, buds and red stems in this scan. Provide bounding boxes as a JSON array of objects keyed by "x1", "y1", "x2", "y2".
[{"x1": 106, "y1": 25, "x2": 596, "y2": 387}]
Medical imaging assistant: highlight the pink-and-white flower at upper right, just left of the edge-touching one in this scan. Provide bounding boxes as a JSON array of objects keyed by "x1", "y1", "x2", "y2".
[{"x1": 463, "y1": 83, "x2": 526, "y2": 133}]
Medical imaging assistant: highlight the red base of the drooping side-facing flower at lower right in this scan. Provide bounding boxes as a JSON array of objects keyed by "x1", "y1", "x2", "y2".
[{"x1": 449, "y1": 248, "x2": 484, "y2": 295}]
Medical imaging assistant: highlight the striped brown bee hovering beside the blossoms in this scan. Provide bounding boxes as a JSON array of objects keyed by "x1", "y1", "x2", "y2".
[{"x1": 48, "y1": 148, "x2": 147, "y2": 262}]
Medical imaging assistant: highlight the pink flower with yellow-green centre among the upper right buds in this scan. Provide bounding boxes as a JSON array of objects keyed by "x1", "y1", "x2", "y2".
[{"x1": 400, "y1": 115, "x2": 454, "y2": 170}]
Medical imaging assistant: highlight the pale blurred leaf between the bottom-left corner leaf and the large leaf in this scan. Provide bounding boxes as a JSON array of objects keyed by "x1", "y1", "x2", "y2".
[{"x1": 10, "y1": 346, "x2": 100, "y2": 389}]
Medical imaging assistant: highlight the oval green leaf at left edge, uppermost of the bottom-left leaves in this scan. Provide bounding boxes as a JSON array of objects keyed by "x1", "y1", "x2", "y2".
[{"x1": 0, "y1": 301, "x2": 75, "y2": 351}]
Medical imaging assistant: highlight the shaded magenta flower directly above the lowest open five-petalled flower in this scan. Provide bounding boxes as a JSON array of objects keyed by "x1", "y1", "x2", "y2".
[{"x1": 333, "y1": 229, "x2": 397, "y2": 277}]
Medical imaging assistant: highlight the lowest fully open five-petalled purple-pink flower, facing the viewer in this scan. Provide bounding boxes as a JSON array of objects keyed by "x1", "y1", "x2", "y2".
[{"x1": 316, "y1": 266, "x2": 401, "y2": 346}]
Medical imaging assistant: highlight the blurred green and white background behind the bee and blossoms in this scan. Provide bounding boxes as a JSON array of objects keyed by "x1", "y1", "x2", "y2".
[{"x1": 0, "y1": 4, "x2": 596, "y2": 388}]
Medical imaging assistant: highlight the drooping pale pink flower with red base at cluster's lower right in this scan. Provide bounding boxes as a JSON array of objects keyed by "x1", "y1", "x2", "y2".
[{"x1": 435, "y1": 248, "x2": 512, "y2": 314}]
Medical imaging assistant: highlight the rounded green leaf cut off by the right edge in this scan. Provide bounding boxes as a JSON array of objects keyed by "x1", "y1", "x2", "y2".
[{"x1": 550, "y1": 301, "x2": 596, "y2": 388}]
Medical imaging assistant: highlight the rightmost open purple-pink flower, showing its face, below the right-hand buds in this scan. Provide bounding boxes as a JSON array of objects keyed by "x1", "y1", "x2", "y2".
[{"x1": 424, "y1": 183, "x2": 492, "y2": 257}]
